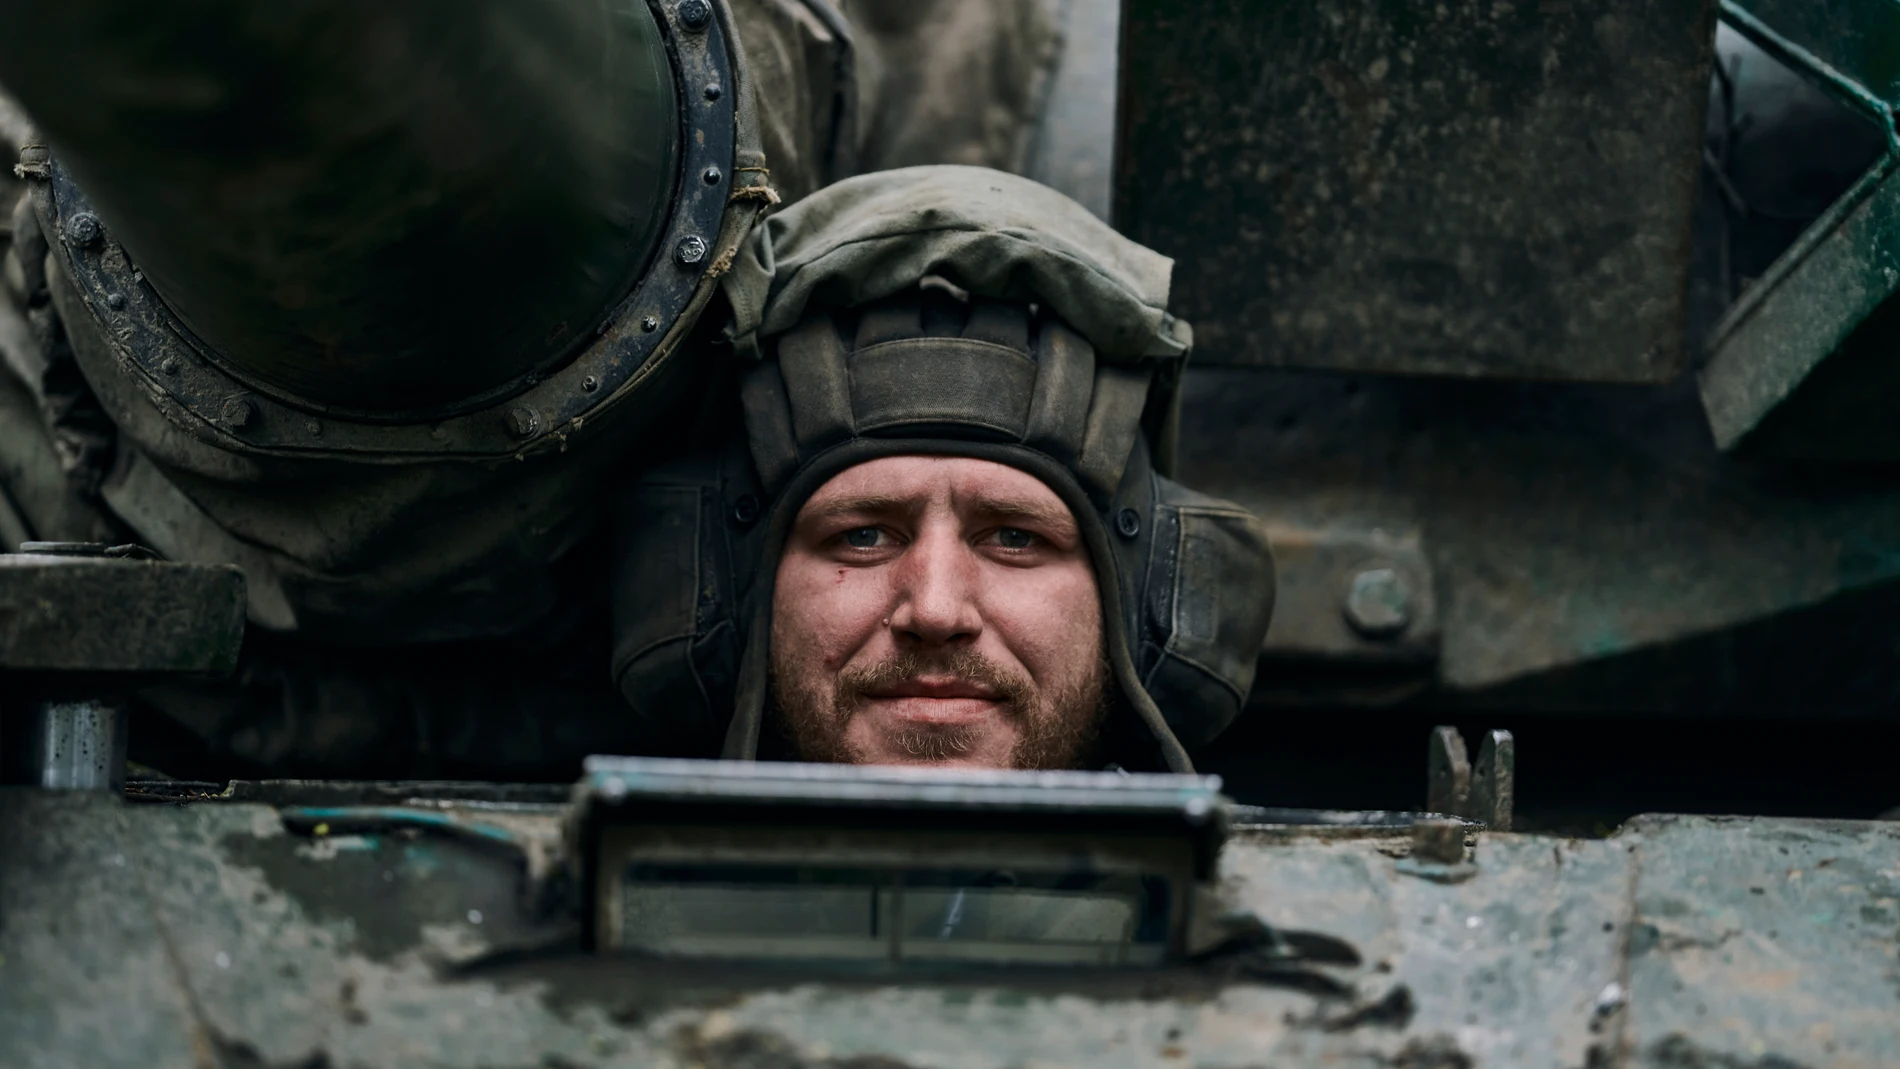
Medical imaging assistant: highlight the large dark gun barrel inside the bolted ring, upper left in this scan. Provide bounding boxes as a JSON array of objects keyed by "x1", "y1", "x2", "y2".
[{"x1": 0, "y1": 0, "x2": 680, "y2": 412}]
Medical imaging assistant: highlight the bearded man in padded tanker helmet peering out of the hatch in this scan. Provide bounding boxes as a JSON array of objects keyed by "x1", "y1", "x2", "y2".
[{"x1": 612, "y1": 167, "x2": 1273, "y2": 771}]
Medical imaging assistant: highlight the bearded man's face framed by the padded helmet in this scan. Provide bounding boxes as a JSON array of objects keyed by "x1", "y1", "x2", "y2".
[{"x1": 771, "y1": 456, "x2": 1108, "y2": 769}]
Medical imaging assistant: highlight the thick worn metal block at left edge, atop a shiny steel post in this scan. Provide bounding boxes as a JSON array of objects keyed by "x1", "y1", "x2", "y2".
[{"x1": 0, "y1": 553, "x2": 245, "y2": 672}]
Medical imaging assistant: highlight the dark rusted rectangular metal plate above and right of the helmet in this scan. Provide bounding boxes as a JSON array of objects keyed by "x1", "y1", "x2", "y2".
[{"x1": 1115, "y1": 0, "x2": 1716, "y2": 382}]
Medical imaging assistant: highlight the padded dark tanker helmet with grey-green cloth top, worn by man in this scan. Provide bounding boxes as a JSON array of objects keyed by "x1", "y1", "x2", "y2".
[{"x1": 612, "y1": 167, "x2": 1273, "y2": 771}]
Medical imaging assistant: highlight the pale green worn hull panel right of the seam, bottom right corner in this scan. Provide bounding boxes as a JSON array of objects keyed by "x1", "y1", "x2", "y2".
[{"x1": 1619, "y1": 816, "x2": 1900, "y2": 1069}]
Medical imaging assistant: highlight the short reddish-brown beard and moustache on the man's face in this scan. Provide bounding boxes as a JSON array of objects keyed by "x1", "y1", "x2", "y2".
[{"x1": 771, "y1": 649, "x2": 1108, "y2": 769}]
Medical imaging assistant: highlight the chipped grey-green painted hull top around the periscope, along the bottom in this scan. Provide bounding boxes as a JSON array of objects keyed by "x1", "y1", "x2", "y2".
[{"x1": 0, "y1": 790, "x2": 1900, "y2": 1069}]
